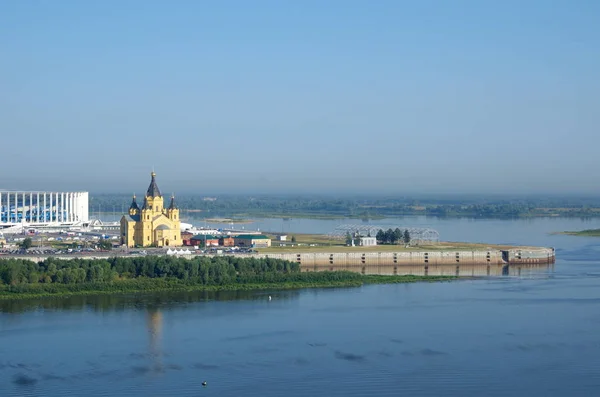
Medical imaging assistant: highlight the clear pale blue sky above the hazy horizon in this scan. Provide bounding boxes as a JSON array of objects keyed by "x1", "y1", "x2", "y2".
[{"x1": 0, "y1": 0, "x2": 600, "y2": 194}]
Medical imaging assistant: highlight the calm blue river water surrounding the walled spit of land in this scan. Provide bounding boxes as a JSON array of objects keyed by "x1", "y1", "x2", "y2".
[{"x1": 0, "y1": 218, "x2": 600, "y2": 397}]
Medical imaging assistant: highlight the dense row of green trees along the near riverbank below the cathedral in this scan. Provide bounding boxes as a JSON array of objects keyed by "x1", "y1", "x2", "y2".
[{"x1": 0, "y1": 256, "x2": 300, "y2": 285}]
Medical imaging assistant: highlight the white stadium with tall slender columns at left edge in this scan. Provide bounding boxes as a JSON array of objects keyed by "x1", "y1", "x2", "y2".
[{"x1": 0, "y1": 191, "x2": 89, "y2": 227}]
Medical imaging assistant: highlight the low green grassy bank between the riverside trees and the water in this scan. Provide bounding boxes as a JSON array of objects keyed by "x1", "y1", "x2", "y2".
[{"x1": 0, "y1": 272, "x2": 456, "y2": 300}]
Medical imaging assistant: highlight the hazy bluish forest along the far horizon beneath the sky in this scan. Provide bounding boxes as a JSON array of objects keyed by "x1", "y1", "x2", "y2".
[{"x1": 90, "y1": 194, "x2": 600, "y2": 218}]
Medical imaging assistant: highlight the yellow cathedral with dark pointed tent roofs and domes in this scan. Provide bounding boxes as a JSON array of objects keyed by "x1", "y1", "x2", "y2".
[{"x1": 121, "y1": 172, "x2": 183, "y2": 247}]
